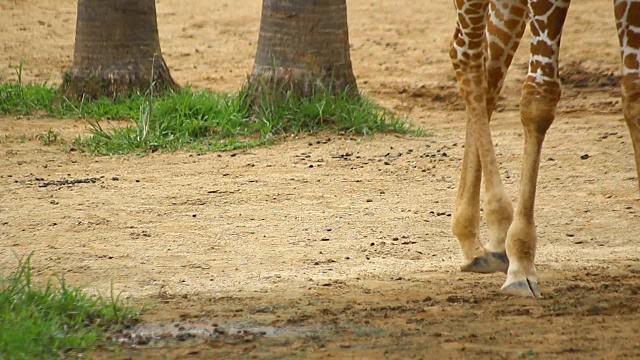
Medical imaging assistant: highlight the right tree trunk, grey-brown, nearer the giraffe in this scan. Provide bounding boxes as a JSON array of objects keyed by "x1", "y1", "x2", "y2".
[{"x1": 249, "y1": 0, "x2": 357, "y2": 98}]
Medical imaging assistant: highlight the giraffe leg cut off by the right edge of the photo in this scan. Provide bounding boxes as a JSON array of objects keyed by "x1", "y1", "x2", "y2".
[{"x1": 614, "y1": 0, "x2": 640, "y2": 194}]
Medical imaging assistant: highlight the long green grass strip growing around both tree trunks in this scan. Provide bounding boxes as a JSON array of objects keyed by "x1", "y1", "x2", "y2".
[{"x1": 0, "y1": 77, "x2": 425, "y2": 155}]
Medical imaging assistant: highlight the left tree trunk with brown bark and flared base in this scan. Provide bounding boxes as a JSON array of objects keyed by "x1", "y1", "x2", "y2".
[{"x1": 60, "y1": 0, "x2": 178, "y2": 98}]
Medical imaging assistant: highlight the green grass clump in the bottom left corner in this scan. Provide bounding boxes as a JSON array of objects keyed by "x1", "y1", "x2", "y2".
[{"x1": 0, "y1": 256, "x2": 138, "y2": 359}]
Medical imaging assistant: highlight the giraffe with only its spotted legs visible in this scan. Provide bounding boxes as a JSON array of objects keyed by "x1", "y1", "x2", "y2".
[{"x1": 450, "y1": 0, "x2": 640, "y2": 297}]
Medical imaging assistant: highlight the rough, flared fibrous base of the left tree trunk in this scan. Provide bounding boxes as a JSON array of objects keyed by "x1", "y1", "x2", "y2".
[{"x1": 59, "y1": 57, "x2": 179, "y2": 99}]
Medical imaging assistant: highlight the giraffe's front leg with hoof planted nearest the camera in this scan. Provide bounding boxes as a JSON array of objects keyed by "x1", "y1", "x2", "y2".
[{"x1": 502, "y1": 0, "x2": 569, "y2": 297}]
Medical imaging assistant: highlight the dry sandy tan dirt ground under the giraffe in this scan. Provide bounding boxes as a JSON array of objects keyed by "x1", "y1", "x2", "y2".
[{"x1": 0, "y1": 0, "x2": 640, "y2": 359}]
